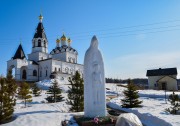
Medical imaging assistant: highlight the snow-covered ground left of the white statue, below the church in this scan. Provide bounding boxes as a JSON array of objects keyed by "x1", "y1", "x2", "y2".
[{"x1": 2, "y1": 84, "x2": 80, "y2": 126}]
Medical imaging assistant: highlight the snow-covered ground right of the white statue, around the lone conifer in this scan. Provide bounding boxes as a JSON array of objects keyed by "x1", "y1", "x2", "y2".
[{"x1": 106, "y1": 84, "x2": 180, "y2": 126}]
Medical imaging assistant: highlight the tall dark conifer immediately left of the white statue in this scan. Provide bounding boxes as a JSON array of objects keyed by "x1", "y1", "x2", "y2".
[{"x1": 67, "y1": 71, "x2": 84, "y2": 112}]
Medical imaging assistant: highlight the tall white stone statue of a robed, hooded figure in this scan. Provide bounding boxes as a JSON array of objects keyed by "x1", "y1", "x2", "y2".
[{"x1": 84, "y1": 36, "x2": 106, "y2": 117}]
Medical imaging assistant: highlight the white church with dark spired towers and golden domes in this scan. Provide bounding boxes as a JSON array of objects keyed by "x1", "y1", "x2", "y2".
[{"x1": 7, "y1": 15, "x2": 83, "y2": 83}]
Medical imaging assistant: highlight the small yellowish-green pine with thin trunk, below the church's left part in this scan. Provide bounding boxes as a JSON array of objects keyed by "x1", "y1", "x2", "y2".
[{"x1": 18, "y1": 82, "x2": 32, "y2": 107}]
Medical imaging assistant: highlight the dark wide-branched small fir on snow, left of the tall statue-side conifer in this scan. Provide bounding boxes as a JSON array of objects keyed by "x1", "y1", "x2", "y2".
[{"x1": 45, "y1": 80, "x2": 63, "y2": 103}]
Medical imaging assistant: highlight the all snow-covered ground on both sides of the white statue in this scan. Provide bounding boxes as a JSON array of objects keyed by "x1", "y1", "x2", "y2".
[{"x1": 2, "y1": 80, "x2": 180, "y2": 126}]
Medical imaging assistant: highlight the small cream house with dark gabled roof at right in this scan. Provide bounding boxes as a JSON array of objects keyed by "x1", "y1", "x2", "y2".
[{"x1": 146, "y1": 68, "x2": 178, "y2": 90}]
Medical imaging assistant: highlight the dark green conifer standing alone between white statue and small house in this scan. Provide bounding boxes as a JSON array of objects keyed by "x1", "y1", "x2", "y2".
[{"x1": 121, "y1": 79, "x2": 142, "y2": 108}]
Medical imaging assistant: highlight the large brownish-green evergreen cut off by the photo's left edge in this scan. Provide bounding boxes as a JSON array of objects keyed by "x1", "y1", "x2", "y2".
[{"x1": 0, "y1": 71, "x2": 17, "y2": 123}]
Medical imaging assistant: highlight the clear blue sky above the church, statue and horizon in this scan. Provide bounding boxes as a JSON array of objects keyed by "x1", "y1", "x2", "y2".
[{"x1": 0, "y1": 0, "x2": 180, "y2": 79}]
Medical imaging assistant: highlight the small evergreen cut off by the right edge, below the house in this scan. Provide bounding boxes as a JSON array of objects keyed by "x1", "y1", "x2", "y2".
[{"x1": 166, "y1": 92, "x2": 180, "y2": 114}]
